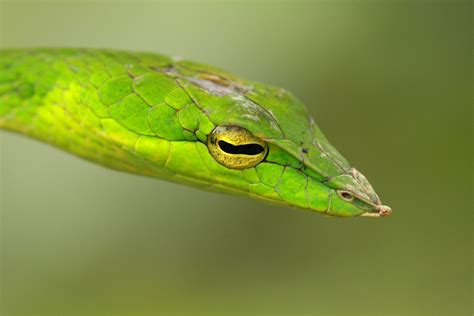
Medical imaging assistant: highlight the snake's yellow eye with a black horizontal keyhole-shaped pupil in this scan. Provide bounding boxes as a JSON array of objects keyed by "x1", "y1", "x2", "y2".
[{"x1": 207, "y1": 126, "x2": 268, "y2": 169}]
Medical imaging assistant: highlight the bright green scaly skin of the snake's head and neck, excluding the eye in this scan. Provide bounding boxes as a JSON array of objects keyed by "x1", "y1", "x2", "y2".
[{"x1": 0, "y1": 49, "x2": 390, "y2": 216}]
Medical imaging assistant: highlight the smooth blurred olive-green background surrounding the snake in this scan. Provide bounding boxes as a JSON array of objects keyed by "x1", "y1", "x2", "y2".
[{"x1": 0, "y1": 0, "x2": 473, "y2": 316}]
